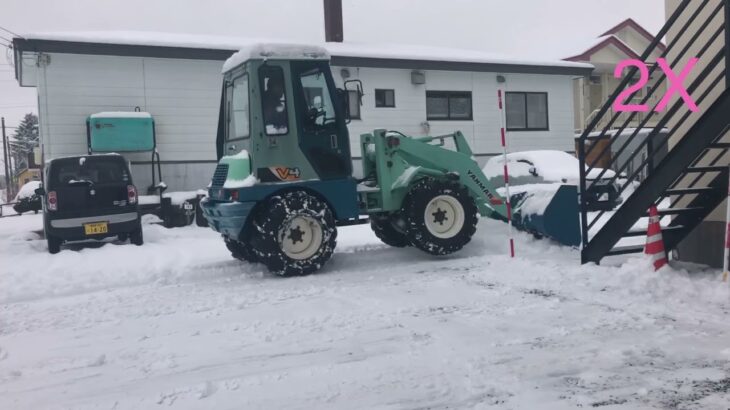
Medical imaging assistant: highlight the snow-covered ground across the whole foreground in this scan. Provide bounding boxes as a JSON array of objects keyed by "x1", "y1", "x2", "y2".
[{"x1": 0, "y1": 215, "x2": 730, "y2": 410}]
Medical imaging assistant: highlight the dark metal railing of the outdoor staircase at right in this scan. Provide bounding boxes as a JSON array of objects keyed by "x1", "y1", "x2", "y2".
[{"x1": 577, "y1": 0, "x2": 730, "y2": 260}]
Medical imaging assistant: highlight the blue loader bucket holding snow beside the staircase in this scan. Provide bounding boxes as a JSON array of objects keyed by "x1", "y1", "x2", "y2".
[{"x1": 510, "y1": 185, "x2": 581, "y2": 247}]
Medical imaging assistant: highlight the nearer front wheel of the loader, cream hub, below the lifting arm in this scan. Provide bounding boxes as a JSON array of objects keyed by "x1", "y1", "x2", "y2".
[{"x1": 403, "y1": 178, "x2": 478, "y2": 255}]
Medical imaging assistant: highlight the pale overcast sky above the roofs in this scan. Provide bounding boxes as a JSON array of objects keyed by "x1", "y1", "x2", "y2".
[{"x1": 0, "y1": 0, "x2": 664, "y2": 141}]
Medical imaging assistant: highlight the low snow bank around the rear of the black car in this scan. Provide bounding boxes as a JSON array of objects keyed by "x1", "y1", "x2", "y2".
[{"x1": 0, "y1": 214, "x2": 229, "y2": 302}]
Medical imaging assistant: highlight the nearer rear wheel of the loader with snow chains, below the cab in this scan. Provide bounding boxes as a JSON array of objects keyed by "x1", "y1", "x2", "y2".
[{"x1": 251, "y1": 191, "x2": 337, "y2": 276}]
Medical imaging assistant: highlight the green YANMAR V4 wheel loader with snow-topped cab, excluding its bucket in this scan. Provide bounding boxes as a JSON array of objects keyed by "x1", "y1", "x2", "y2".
[{"x1": 201, "y1": 44, "x2": 580, "y2": 276}]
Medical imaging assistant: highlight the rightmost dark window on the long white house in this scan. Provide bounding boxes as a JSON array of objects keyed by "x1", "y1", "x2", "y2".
[{"x1": 505, "y1": 92, "x2": 548, "y2": 131}]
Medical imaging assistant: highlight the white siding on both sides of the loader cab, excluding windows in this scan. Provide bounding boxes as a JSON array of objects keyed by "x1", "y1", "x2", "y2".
[{"x1": 38, "y1": 53, "x2": 574, "y2": 190}]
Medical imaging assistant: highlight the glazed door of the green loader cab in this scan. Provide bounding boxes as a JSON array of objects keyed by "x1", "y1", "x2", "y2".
[{"x1": 292, "y1": 61, "x2": 352, "y2": 179}]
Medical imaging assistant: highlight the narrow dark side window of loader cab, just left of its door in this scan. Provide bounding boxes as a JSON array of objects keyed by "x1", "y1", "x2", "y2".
[{"x1": 259, "y1": 65, "x2": 289, "y2": 135}]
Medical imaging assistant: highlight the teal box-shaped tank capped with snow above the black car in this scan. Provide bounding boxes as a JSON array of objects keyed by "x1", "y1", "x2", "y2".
[{"x1": 87, "y1": 111, "x2": 155, "y2": 152}]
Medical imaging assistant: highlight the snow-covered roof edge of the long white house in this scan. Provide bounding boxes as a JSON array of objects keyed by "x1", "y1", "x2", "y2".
[{"x1": 13, "y1": 31, "x2": 593, "y2": 77}]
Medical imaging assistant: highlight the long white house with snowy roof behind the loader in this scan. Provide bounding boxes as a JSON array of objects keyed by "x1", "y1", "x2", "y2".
[{"x1": 13, "y1": 32, "x2": 593, "y2": 190}]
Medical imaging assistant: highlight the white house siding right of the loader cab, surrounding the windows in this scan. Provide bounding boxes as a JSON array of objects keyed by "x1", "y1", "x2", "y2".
[{"x1": 333, "y1": 67, "x2": 574, "y2": 157}]
